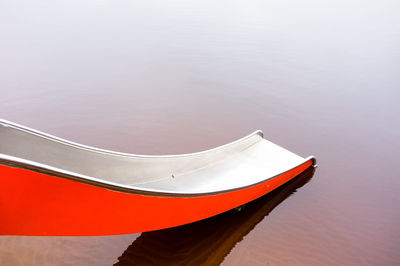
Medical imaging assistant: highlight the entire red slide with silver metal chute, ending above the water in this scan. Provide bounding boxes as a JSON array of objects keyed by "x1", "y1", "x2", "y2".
[{"x1": 0, "y1": 120, "x2": 316, "y2": 236}]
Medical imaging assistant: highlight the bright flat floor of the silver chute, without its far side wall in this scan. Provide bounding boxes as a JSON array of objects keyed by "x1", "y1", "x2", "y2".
[{"x1": 130, "y1": 139, "x2": 304, "y2": 193}]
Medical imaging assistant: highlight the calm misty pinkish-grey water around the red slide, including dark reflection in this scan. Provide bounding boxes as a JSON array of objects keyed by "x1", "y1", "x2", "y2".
[{"x1": 0, "y1": 0, "x2": 400, "y2": 265}]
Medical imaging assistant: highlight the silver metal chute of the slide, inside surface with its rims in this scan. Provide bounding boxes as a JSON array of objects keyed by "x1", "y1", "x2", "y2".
[{"x1": 0, "y1": 120, "x2": 312, "y2": 194}]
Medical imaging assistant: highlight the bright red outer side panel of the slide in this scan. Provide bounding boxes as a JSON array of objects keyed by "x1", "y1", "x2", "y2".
[{"x1": 0, "y1": 160, "x2": 312, "y2": 236}]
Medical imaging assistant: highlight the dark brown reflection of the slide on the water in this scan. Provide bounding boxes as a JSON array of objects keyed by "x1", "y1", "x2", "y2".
[{"x1": 115, "y1": 167, "x2": 314, "y2": 266}]
